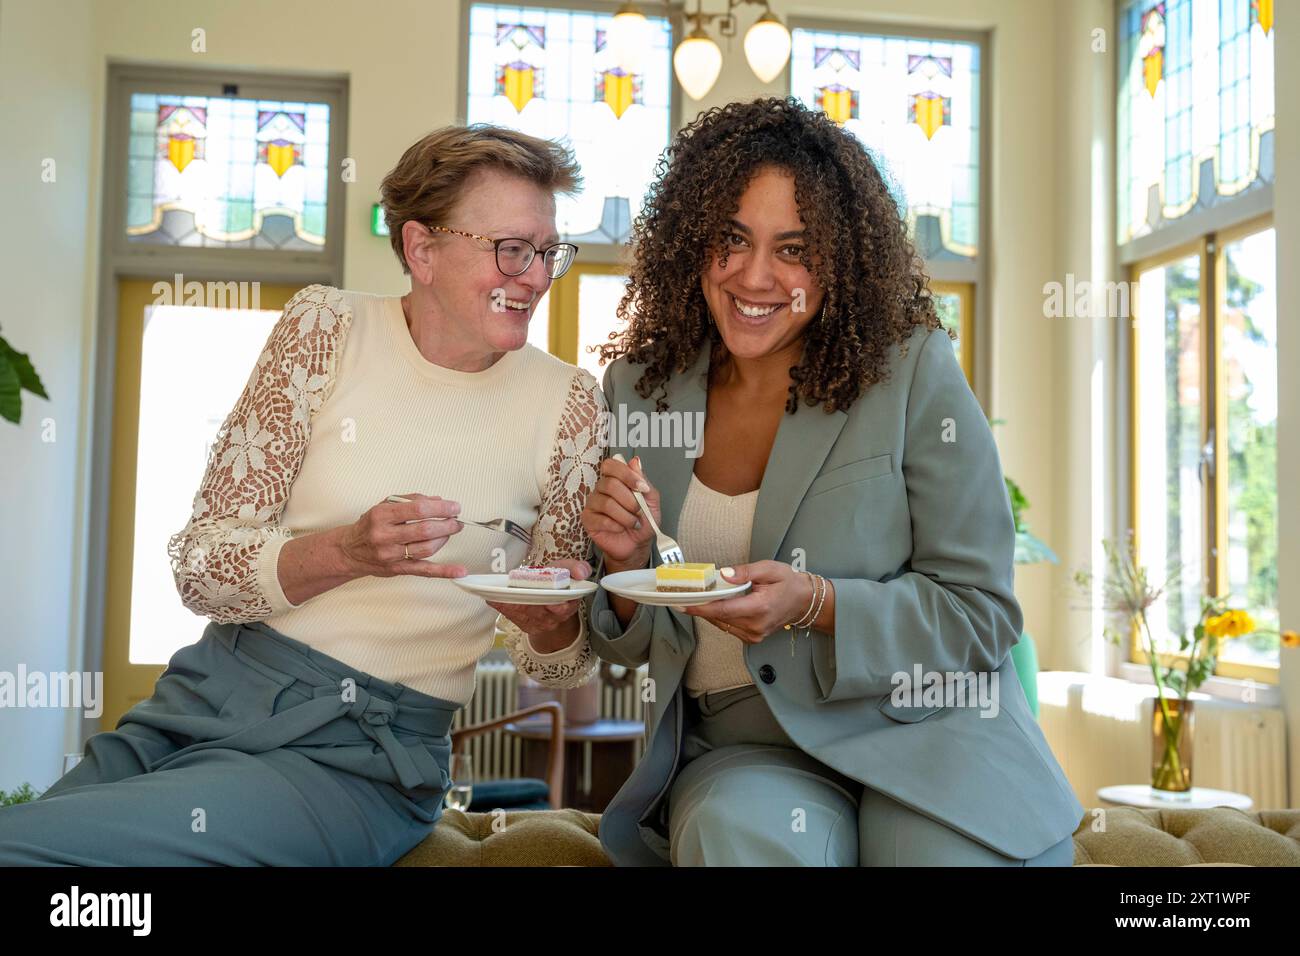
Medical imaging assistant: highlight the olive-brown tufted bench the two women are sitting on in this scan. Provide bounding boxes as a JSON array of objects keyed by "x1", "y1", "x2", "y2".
[{"x1": 395, "y1": 806, "x2": 1300, "y2": 866}]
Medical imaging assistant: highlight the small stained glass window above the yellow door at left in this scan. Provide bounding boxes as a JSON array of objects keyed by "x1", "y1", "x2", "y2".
[{"x1": 126, "y1": 92, "x2": 330, "y2": 251}]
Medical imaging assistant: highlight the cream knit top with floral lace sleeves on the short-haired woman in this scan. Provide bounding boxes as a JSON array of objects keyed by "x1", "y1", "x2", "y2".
[{"x1": 169, "y1": 286, "x2": 603, "y2": 704}]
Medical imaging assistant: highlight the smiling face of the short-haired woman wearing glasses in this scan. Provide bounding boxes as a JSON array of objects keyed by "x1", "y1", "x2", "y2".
[{"x1": 411, "y1": 168, "x2": 559, "y2": 352}]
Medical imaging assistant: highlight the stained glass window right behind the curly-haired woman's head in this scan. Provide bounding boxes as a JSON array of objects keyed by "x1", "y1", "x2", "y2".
[{"x1": 790, "y1": 27, "x2": 980, "y2": 261}]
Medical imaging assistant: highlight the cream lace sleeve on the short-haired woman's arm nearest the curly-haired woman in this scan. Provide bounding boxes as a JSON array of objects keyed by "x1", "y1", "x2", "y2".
[{"x1": 497, "y1": 371, "x2": 605, "y2": 687}]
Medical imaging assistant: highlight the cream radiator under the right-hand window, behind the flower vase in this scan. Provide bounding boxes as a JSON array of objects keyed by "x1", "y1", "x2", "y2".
[{"x1": 1039, "y1": 671, "x2": 1287, "y2": 810}]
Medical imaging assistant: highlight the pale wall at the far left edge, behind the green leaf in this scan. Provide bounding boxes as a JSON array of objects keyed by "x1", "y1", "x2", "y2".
[{"x1": 0, "y1": 0, "x2": 98, "y2": 790}]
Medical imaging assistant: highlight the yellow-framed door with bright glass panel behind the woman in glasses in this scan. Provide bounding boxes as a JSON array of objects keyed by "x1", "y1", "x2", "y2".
[{"x1": 100, "y1": 278, "x2": 298, "y2": 730}]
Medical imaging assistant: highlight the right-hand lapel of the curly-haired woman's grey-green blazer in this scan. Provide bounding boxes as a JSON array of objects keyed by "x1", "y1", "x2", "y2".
[{"x1": 749, "y1": 405, "x2": 849, "y2": 562}]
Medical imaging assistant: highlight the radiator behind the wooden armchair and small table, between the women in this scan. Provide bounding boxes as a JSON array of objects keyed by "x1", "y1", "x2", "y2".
[{"x1": 451, "y1": 652, "x2": 645, "y2": 783}]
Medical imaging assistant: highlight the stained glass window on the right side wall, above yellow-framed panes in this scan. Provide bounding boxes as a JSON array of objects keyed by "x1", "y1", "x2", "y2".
[{"x1": 1118, "y1": 0, "x2": 1273, "y2": 243}]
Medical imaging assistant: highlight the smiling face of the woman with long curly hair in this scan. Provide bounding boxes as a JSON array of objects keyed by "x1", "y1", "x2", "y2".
[{"x1": 699, "y1": 166, "x2": 826, "y2": 359}]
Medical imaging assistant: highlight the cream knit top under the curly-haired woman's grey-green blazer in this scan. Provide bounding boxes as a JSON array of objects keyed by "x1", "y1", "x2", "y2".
[{"x1": 677, "y1": 475, "x2": 758, "y2": 697}]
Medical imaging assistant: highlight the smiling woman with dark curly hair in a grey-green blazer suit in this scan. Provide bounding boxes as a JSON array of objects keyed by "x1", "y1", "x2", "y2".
[{"x1": 582, "y1": 99, "x2": 1083, "y2": 866}]
